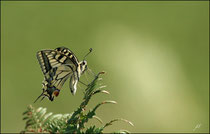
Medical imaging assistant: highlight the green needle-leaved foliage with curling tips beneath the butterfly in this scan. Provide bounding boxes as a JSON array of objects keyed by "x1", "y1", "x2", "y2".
[{"x1": 21, "y1": 72, "x2": 133, "y2": 133}]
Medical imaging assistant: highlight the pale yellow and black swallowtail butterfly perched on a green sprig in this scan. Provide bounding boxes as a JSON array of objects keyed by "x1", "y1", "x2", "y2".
[{"x1": 34, "y1": 47, "x2": 92, "y2": 103}]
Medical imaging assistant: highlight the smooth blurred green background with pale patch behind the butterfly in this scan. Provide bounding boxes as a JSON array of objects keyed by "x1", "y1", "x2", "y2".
[{"x1": 1, "y1": 1, "x2": 209, "y2": 133}]
